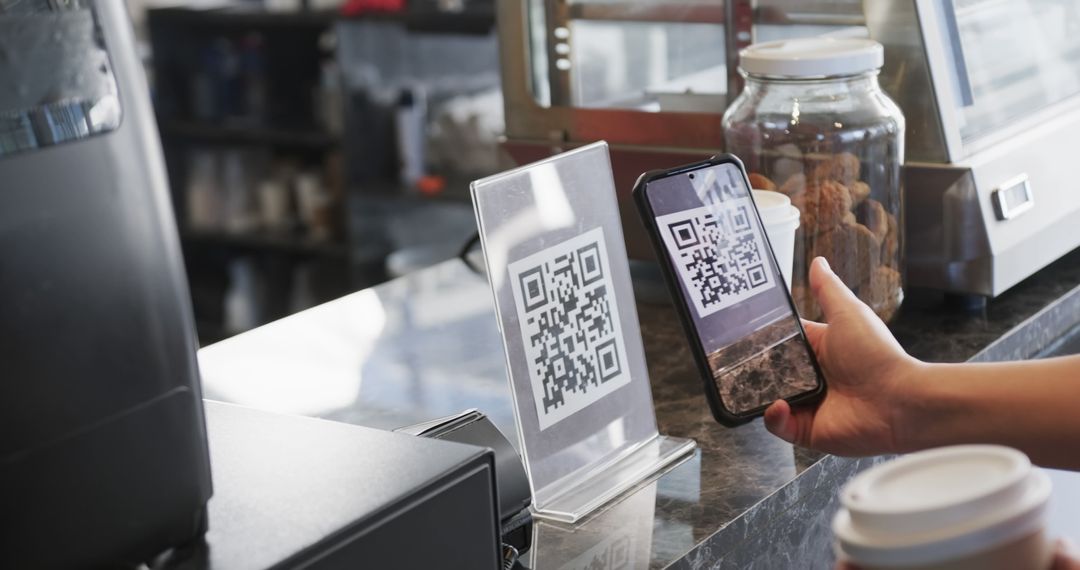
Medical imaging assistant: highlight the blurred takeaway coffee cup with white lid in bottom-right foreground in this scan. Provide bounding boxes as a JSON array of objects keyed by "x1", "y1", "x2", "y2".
[{"x1": 833, "y1": 445, "x2": 1052, "y2": 570}]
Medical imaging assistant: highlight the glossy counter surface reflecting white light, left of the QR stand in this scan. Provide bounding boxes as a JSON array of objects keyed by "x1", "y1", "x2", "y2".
[{"x1": 199, "y1": 260, "x2": 515, "y2": 436}]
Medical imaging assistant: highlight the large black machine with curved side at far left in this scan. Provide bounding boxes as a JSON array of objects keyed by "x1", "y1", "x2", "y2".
[{"x1": 0, "y1": 0, "x2": 211, "y2": 568}]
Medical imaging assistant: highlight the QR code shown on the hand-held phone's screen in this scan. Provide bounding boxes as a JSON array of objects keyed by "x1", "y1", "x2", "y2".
[{"x1": 657, "y1": 196, "x2": 775, "y2": 317}]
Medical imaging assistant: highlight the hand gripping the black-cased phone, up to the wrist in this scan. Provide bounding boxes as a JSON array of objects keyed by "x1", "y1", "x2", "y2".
[{"x1": 765, "y1": 257, "x2": 921, "y2": 456}]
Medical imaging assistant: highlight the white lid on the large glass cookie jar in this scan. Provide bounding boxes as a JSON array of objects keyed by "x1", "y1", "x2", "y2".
[{"x1": 739, "y1": 38, "x2": 885, "y2": 79}]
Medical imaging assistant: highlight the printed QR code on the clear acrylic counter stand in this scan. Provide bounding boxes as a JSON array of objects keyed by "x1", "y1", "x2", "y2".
[{"x1": 509, "y1": 228, "x2": 630, "y2": 430}]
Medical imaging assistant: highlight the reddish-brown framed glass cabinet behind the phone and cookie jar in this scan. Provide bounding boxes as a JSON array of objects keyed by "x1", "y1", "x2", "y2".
[{"x1": 498, "y1": 0, "x2": 866, "y2": 259}]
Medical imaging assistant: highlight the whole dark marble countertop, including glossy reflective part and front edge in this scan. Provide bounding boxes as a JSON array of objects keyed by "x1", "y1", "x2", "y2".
[{"x1": 199, "y1": 247, "x2": 1080, "y2": 569}]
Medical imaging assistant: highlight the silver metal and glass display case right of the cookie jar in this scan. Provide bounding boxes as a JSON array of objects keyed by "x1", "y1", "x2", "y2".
[{"x1": 865, "y1": 0, "x2": 1080, "y2": 297}]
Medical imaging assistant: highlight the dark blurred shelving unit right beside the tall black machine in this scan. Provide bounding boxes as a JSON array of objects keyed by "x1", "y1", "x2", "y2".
[{"x1": 147, "y1": 4, "x2": 347, "y2": 344}]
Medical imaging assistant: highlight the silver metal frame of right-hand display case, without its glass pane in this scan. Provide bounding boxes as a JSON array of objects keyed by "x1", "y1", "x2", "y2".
[{"x1": 866, "y1": 0, "x2": 1080, "y2": 297}]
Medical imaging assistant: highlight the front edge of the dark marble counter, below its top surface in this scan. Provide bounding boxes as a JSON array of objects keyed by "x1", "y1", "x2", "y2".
[{"x1": 667, "y1": 286, "x2": 1080, "y2": 570}]
